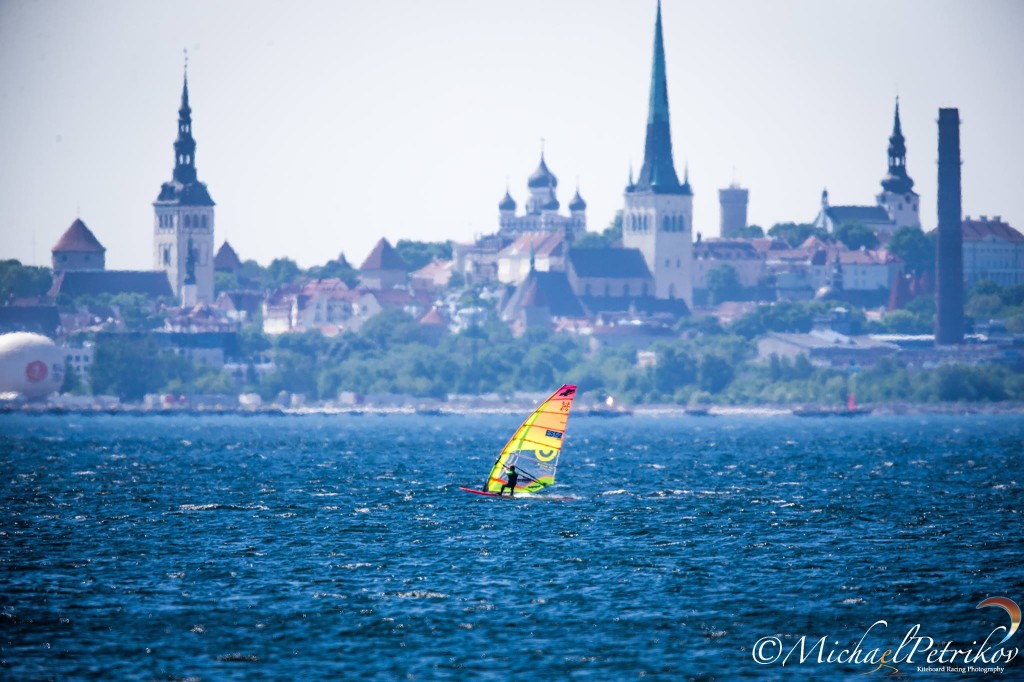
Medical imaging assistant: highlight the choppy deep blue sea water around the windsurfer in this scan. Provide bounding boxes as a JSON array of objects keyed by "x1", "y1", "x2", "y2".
[{"x1": 0, "y1": 415, "x2": 1024, "y2": 680}]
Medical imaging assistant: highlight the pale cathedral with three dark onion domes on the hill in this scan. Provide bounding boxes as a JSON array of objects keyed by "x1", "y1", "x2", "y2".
[{"x1": 498, "y1": 151, "x2": 587, "y2": 242}]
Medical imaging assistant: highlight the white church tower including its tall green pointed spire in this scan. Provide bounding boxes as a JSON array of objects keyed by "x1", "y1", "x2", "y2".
[{"x1": 623, "y1": 2, "x2": 693, "y2": 309}]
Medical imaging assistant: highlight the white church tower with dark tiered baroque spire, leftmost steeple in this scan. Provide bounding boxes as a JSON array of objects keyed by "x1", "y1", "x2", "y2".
[{"x1": 153, "y1": 65, "x2": 214, "y2": 304}]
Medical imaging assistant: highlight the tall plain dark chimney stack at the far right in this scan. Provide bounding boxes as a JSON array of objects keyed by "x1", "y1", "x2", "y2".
[{"x1": 935, "y1": 109, "x2": 964, "y2": 346}]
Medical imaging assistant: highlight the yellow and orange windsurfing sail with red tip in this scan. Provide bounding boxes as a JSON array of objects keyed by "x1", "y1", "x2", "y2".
[{"x1": 483, "y1": 384, "x2": 577, "y2": 495}]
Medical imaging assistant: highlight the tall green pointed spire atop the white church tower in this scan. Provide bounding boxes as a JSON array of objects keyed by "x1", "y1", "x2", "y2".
[{"x1": 634, "y1": 0, "x2": 691, "y2": 195}]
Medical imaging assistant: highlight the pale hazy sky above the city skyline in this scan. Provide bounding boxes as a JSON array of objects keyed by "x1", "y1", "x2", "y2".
[{"x1": 0, "y1": 0, "x2": 1024, "y2": 269}]
